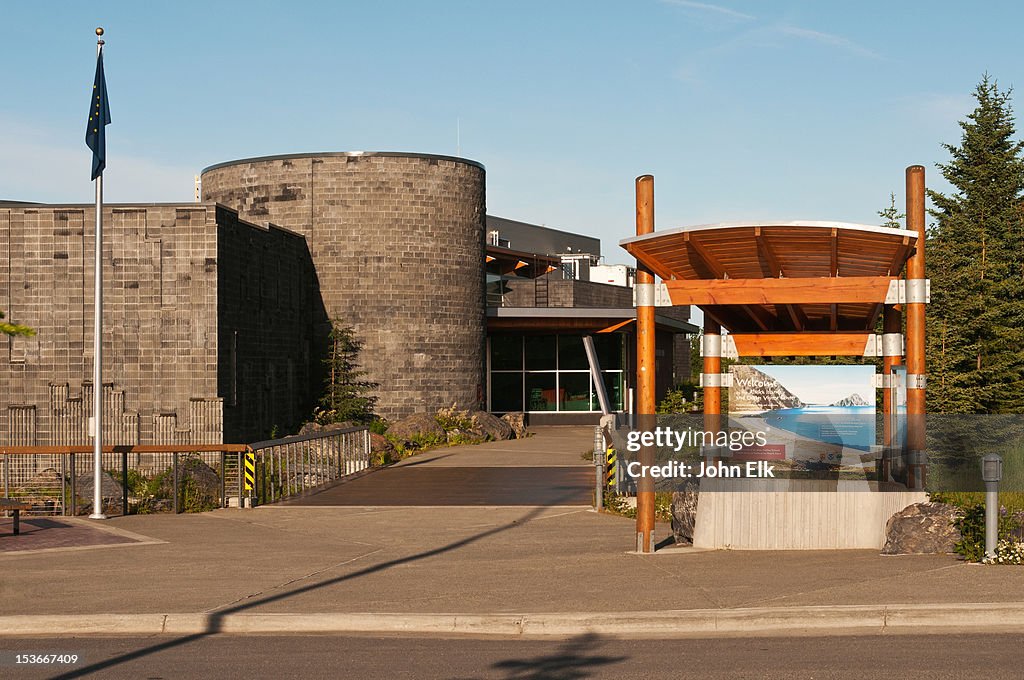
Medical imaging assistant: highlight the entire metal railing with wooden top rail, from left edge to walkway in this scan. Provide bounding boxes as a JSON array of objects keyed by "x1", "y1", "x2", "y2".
[{"x1": 0, "y1": 427, "x2": 370, "y2": 515}]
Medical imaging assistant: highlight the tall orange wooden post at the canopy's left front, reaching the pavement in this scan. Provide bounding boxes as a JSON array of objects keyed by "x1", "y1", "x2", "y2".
[{"x1": 636, "y1": 175, "x2": 656, "y2": 553}]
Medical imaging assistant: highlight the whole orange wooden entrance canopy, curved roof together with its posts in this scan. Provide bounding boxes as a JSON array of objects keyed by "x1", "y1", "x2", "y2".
[{"x1": 620, "y1": 166, "x2": 928, "y2": 552}]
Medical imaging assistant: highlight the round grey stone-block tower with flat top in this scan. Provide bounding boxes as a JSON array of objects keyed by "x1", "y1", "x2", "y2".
[{"x1": 203, "y1": 152, "x2": 485, "y2": 419}]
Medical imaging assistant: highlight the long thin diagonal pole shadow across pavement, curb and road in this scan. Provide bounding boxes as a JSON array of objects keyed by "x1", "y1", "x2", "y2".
[{"x1": 51, "y1": 491, "x2": 584, "y2": 680}]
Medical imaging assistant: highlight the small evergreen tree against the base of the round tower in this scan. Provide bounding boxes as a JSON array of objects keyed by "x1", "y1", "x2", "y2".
[{"x1": 316, "y1": 322, "x2": 377, "y2": 424}]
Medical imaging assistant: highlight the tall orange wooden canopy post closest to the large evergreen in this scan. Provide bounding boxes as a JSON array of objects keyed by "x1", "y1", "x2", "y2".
[{"x1": 906, "y1": 165, "x2": 927, "y2": 488}]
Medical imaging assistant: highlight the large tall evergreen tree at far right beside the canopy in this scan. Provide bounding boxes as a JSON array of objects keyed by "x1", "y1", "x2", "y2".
[{"x1": 927, "y1": 74, "x2": 1024, "y2": 413}]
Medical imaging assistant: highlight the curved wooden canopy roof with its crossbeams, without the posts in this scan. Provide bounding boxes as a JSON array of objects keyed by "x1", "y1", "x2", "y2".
[{"x1": 621, "y1": 221, "x2": 918, "y2": 355}]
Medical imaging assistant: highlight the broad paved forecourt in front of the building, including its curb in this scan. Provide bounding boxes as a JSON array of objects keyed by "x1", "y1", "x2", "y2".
[{"x1": 0, "y1": 430, "x2": 1024, "y2": 635}]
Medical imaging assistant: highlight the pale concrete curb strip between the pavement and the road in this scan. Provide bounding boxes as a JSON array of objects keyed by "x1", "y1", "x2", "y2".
[{"x1": 0, "y1": 602, "x2": 1024, "y2": 637}]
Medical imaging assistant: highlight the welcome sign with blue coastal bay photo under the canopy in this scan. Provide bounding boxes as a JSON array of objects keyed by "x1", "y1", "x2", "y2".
[{"x1": 729, "y1": 366, "x2": 876, "y2": 464}]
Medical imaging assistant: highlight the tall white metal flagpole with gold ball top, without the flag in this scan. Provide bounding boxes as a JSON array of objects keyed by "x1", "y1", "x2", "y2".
[{"x1": 89, "y1": 28, "x2": 106, "y2": 519}]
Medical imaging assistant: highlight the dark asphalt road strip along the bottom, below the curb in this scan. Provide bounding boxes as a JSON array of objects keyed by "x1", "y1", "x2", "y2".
[{"x1": 0, "y1": 634, "x2": 1024, "y2": 680}]
